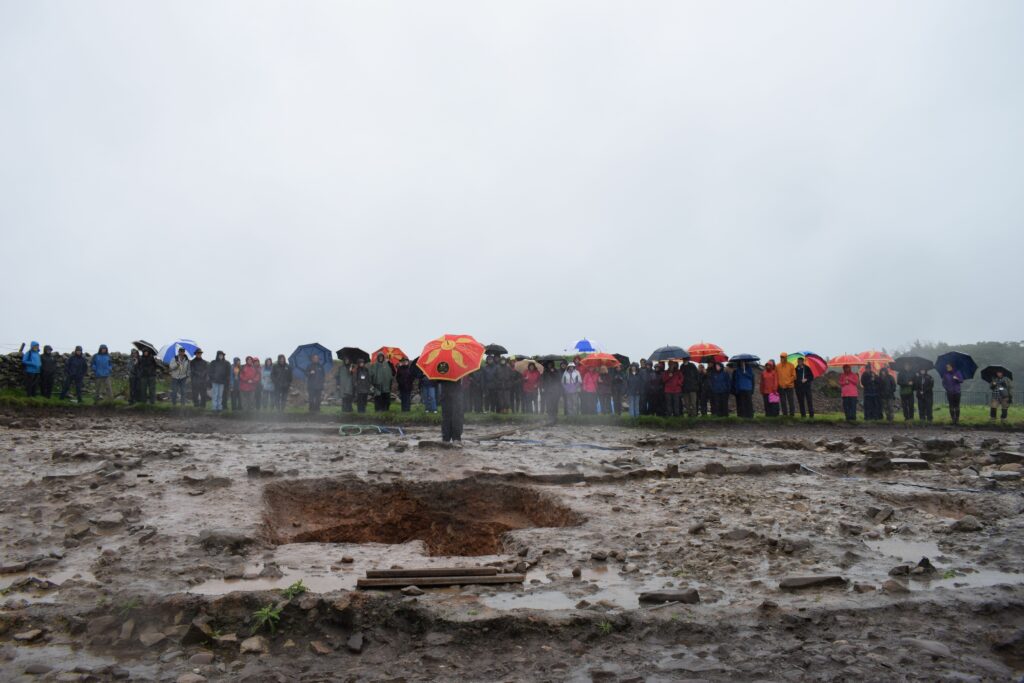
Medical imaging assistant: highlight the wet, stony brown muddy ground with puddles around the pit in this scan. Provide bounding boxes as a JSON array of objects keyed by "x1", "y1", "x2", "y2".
[{"x1": 0, "y1": 414, "x2": 1024, "y2": 683}]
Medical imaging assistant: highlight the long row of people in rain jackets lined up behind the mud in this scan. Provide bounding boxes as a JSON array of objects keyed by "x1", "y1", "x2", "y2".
[{"x1": 22, "y1": 342, "x2": 1013, "y2": 424}]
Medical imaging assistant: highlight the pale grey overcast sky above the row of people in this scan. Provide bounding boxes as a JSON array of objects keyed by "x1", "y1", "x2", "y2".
[{"x1": 0, "y1": 0, "x2": 1024, "y2": 356}]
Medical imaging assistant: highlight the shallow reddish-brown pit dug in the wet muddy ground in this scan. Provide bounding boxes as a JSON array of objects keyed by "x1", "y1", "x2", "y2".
[{"x1": 264, "y1": 478, "x2": 583, "y2": 556}]
